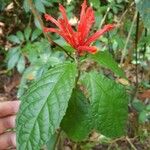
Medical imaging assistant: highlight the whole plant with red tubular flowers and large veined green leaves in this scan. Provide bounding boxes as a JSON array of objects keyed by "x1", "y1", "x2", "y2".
[{"x1": 17, "y1": 0, "x2": 128, "y2": 150}]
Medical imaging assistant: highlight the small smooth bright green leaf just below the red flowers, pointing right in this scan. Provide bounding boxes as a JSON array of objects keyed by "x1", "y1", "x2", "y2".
[{"x1": 90, "y1": 51, "x2": 125, "y2": 78}]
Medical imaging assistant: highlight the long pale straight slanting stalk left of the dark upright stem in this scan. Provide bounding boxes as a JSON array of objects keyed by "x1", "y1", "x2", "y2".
[{"x1": 120, "y1": 12, "x2": 137, "y2": 66}]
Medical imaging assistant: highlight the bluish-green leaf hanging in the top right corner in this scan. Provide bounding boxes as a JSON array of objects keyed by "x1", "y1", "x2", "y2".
[{"x1": 135, "y1": 0, "x2": 150, "y2": 28}]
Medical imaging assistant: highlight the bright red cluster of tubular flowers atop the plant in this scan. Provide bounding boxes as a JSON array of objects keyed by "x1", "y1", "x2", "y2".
[{"x1": 44, "y1": 0, "x2": 115, "y2": 55}]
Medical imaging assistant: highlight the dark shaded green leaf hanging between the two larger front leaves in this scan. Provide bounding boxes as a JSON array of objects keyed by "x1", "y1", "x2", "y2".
[{"x1": 61, "y1": 90, "x2": 91, "y2": 141}]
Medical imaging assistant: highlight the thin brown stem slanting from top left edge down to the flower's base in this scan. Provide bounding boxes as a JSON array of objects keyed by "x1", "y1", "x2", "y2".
[{"x1": 28, "y1": 0, "x2": 74, "y2": 60}]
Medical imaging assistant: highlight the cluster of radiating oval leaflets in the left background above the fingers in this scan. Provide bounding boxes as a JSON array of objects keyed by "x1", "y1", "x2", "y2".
[{"x1": 7, "y1": 27, "x2": 42, "y2": 73}]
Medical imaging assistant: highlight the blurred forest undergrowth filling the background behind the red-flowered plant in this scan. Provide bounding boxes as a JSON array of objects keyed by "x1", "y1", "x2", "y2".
[{"x1": 0, "y1": 0, "x2": 150, "y2": 150}]
